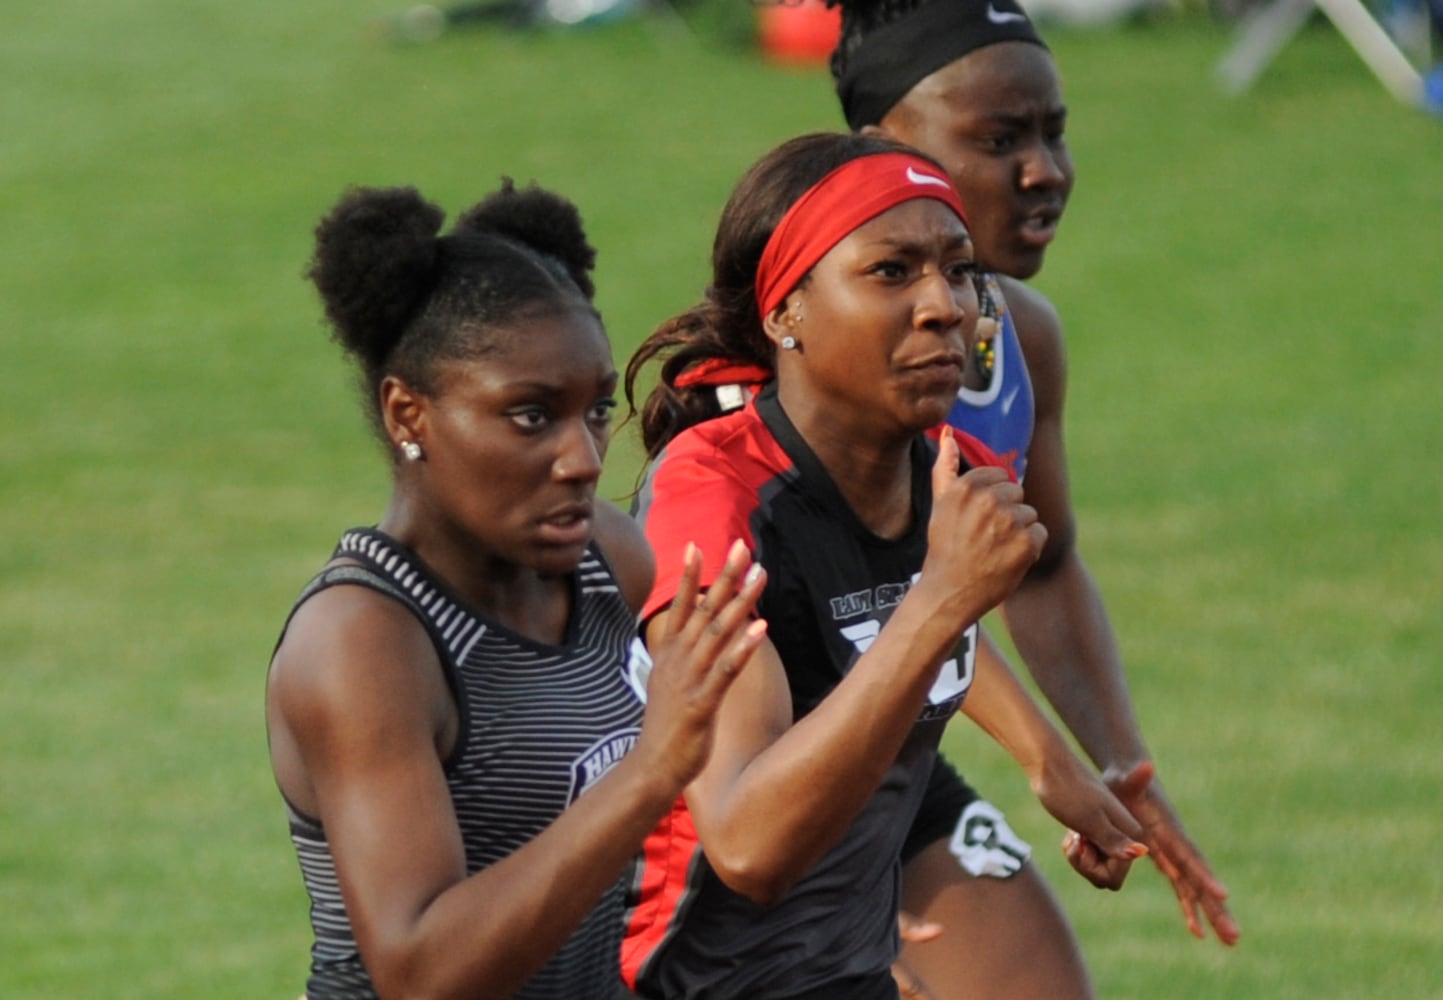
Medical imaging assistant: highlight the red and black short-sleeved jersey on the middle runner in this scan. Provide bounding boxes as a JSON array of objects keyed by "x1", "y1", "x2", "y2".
[{"x1": 622, "y1": 384, "x2": 984, "y2": 1000}]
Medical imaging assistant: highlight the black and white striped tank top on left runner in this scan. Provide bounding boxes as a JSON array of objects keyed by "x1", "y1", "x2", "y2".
[{"x1": 287, "y1": 528, "x2": 642, "y2": 1000}]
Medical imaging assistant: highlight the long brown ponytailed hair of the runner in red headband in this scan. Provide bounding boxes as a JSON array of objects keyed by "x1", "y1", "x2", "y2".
[{"x1": 625, "y1": 133, "x2": 941, "y2": 457}]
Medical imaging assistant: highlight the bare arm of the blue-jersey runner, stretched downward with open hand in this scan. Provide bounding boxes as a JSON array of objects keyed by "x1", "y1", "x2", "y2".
[{"x1": 1001, "y1": 278, "x2": 1240, "y2": 944}]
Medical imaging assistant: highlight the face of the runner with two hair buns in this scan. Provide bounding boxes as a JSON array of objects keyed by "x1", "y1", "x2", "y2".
[{"x1": 423, "y1": 309, "x2": 616, "y2": 574}]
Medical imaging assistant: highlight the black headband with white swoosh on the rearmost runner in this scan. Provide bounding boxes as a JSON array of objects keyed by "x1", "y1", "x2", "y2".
[{"x1": 837, "y1": 0, "x2": 1046, "y2": 131}]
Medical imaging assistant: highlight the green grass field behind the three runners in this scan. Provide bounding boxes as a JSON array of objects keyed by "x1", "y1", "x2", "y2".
[{"x1": 0, "y1": 0, "x2": 1443, "y2": 1000}]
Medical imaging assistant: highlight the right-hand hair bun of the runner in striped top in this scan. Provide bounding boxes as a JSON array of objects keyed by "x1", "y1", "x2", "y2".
[{"x1": 452, "y1": 177, "x2": 596, "y2": 299}]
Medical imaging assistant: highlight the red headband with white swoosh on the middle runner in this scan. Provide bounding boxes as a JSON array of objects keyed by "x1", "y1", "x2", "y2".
[{"x1": 756, "y1": 153, "x2": 967, "y2": 319}]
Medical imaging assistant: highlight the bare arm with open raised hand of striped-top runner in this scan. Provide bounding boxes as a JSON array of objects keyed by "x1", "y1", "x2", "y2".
[{"x1": 267, "y1": 539, "x2": 765, "y2": 997}]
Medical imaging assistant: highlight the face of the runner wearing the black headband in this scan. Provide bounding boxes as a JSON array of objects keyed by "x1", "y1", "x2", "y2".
[{"x1": 882, "y1": 42, "x2": 1074, "y2": 278}]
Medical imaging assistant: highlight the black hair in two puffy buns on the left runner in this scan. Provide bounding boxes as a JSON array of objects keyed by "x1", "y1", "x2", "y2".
[{"x1": 306, "y1": 177, "x2": 596, "y2": 444}]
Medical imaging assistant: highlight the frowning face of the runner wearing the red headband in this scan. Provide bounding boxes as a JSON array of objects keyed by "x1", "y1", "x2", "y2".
[{"x1": 784, "y1": 198, "x2": 977, "y2": 433}]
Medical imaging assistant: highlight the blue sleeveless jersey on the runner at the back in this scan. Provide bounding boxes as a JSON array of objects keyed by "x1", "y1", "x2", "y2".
[{"x1": 947, "y1": 278, "x2": 1035, "y2": 482}]
